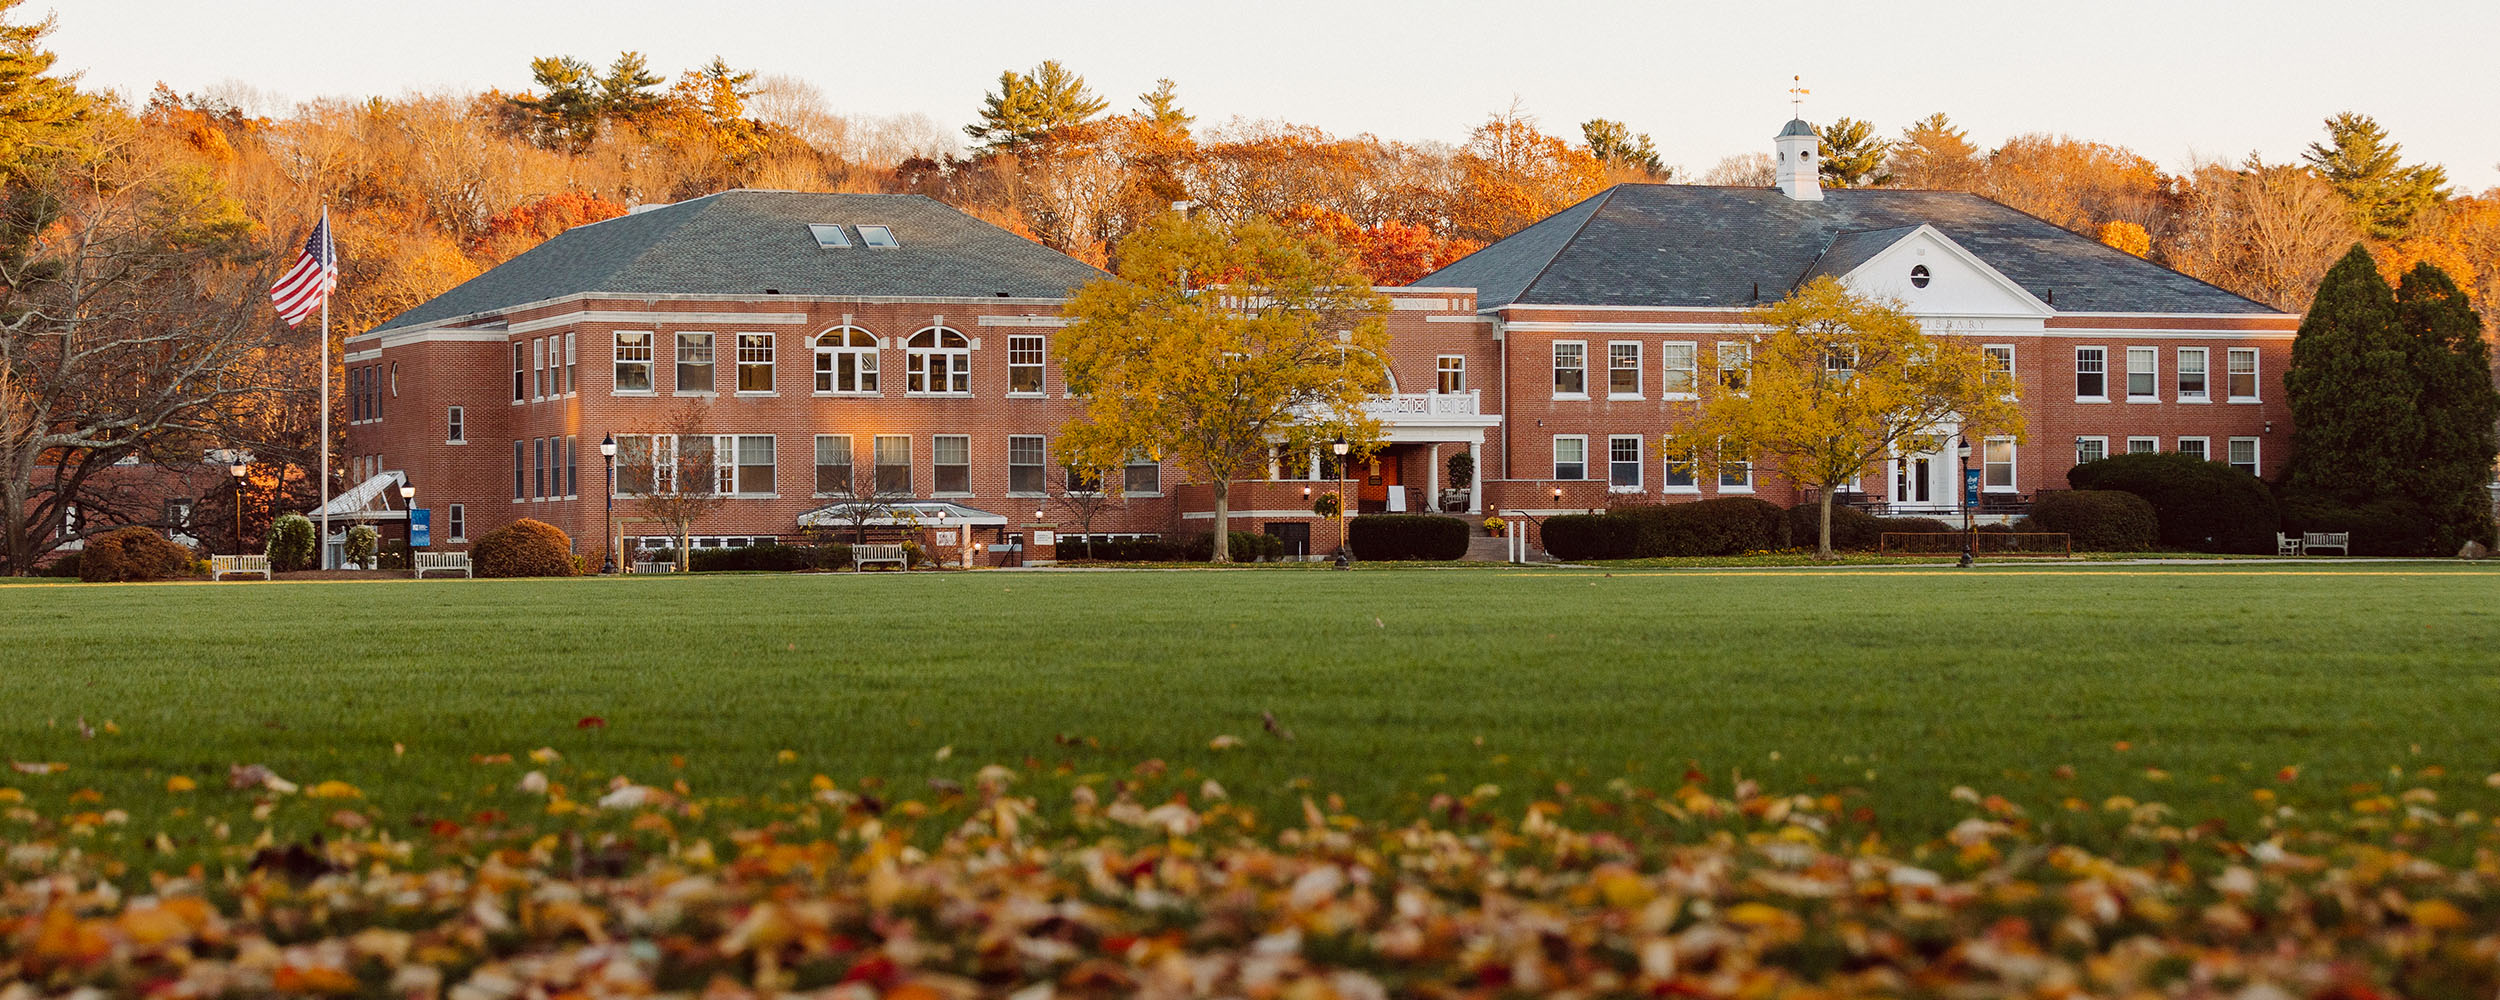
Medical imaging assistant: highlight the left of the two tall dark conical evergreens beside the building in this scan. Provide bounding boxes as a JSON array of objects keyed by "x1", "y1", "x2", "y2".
[{"x1": 2283, "y1": 245, "x2": 2423, "y2": 505}]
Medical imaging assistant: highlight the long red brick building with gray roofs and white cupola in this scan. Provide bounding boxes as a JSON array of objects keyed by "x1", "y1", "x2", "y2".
[{"x1": 345, "y1": 123, "x2": 2298, "y2": 558}]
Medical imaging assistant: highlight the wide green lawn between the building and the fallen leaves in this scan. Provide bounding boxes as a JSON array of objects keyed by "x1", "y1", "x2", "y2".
[{"x1": 0, "y1": 563, "x2": 2500, "y2": 833}]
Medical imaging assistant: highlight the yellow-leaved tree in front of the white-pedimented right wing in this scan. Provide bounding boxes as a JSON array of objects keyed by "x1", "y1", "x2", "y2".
[{"x1": 1663, "y1": 278, "x2": 2023, "y2": 560}]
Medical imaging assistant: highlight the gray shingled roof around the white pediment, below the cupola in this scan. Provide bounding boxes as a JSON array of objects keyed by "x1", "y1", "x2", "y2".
[{"x1": 1418, "y1": 185, "x2": 2275, "y2": 313}]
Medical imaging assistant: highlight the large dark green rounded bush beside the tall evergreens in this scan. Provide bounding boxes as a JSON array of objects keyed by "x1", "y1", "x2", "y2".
[{"x1": 2065, "y1": 453, "x2": 2280, "y2": 553}]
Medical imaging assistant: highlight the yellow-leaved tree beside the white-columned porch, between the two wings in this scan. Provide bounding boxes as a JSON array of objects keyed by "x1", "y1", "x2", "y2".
[{"x1": 1058, "y1": 213, "x2": 1390, "y2": 563}]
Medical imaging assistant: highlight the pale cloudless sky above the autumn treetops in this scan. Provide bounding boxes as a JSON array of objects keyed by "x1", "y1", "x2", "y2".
[{"x1": 39, "y1": 0, "x2": 2500, "y2": 193}]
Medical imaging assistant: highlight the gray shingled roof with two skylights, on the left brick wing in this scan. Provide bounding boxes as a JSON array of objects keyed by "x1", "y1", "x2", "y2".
[{"x1": 378, "y1": 190, "x2": 1103, "y2": 330}]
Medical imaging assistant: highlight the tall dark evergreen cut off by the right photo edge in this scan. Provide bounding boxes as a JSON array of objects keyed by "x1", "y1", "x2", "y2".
[{"x1": 2395, "y1": 263, "x2": 2500, "y2": 555}]
